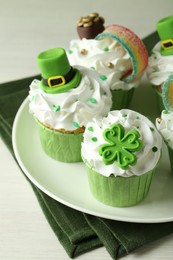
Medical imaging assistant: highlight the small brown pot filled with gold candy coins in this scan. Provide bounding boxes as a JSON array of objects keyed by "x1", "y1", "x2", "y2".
[{"x1": 77, "y1": 13, "x2": 105, "y2": 39}]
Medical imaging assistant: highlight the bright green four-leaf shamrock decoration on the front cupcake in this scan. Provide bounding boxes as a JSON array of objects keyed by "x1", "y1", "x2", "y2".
[{"x1": 99, "y1": 124, "x2": 142, "y2": 169}]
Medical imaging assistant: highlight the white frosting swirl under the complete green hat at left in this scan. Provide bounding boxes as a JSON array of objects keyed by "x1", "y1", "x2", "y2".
[{"x1": 29, "y1": 66, "x2": 112, "y2": 130}]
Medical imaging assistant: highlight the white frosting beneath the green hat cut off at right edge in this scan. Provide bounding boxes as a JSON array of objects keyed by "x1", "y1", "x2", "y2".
[{"x1": 147, "y1": 42, "x2": 173, "y2": 86}]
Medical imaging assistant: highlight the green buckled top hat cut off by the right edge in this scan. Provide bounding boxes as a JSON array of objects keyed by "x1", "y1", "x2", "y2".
[{"x1": 157, "y1": 16, "x2": 173, "y2": 56}]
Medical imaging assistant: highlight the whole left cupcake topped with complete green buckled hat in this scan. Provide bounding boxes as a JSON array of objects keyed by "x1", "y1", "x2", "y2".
[{"x1": 29, "y1": 48, "x2": 112, "y2": 162}]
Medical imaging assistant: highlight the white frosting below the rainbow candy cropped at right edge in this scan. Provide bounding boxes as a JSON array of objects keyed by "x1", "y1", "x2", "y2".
[{"x1": 156, "y1": 110, "x2": 173, "y2": 149}]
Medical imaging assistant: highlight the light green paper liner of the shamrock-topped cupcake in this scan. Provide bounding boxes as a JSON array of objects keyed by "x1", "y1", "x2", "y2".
[{"x1": 86, "y1": 166, "x2": 154, "y2": 207}]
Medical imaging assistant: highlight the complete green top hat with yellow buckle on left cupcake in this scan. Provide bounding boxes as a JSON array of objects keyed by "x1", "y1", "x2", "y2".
[{"x1": 37, "y1": 48, "x2": 81, "y2": 94}]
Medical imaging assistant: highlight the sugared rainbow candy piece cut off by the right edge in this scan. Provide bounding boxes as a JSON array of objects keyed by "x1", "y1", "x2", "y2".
[{"x1": 162, "y1": 74, "x2": 173, "y2": 110}]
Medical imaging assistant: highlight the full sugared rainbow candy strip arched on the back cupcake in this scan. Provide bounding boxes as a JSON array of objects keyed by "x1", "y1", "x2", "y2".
[{"x1": 96, "y1": 24, "x2": 148, "y2": 83}]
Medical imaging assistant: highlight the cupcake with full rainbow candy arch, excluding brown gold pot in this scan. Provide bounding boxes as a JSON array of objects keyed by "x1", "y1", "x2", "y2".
[{"x1": 67, "y1": 16, "x2": 148, "y2": 110}]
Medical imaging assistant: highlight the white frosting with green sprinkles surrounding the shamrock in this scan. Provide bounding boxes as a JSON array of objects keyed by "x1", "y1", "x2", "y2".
[{"x1": 82, "y1": 109, "x2": 162, "y2": 177}]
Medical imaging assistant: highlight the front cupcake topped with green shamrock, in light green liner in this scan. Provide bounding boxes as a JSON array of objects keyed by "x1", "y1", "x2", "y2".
[{"x1": 82, "y1": 109, "x2": 162, "y2": 207}]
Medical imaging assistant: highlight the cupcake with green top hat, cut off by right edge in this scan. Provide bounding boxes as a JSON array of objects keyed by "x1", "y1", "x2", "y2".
[{"x1": 147, "y1": 16, "x2": 173, "y2": 113}]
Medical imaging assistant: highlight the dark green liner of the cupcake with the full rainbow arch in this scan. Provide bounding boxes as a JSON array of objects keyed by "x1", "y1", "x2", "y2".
[{"x1": 111, "y1": 88, "x2": 134, "y2": 110}]
